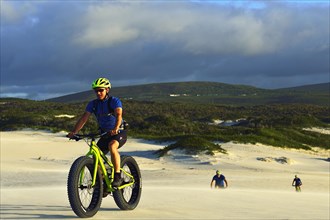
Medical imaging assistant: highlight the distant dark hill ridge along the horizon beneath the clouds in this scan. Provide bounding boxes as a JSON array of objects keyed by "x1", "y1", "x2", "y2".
[{"x1": 46, "y1": 82, "x2": 330, "y2": 106}]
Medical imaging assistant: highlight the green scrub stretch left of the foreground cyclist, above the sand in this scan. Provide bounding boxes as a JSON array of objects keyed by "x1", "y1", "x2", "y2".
[{"x1": 0, "y1": 99, "x2": 97, "y2": 132}]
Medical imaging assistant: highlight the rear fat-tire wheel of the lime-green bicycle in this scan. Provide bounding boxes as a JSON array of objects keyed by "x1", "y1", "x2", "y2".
[{"x1": 113, "y1": 156, "x2": 142, "y2": 210}]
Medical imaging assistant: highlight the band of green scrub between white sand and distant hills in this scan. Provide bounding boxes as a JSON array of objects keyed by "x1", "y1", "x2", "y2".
[{"x1": 0, "y1": 99, "x2": 330, "y2": 153}]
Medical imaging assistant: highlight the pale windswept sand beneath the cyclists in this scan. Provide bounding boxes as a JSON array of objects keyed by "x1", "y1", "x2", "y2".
[{"x1": 0, "y1": 130, "x2": 330, "y2": 219}]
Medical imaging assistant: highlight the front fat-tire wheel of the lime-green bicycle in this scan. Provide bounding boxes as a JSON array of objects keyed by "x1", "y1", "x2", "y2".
[{"x1": 67, "y1": 156, "x2": 103, "y2": 218}]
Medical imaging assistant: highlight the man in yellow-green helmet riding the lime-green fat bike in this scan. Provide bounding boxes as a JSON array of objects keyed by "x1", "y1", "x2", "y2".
[{"x1": 68, "y1": 78, "x2": 127, "y2": 187}]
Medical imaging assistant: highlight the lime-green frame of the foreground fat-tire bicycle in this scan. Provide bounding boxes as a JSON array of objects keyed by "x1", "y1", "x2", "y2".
[{"x1": 80, "y1": 139, "x2": 135, "y2": 192}]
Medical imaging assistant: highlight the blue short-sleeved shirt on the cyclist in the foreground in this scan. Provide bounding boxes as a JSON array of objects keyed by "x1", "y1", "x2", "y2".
[{"x1": 86, "y1": 97, "x2": 123, "y2": 131}]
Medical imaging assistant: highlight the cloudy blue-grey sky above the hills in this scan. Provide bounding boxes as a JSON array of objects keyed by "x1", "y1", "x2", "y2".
[{"x1": 0, "y1": 0, "x2": 330, "y2": 100}]
